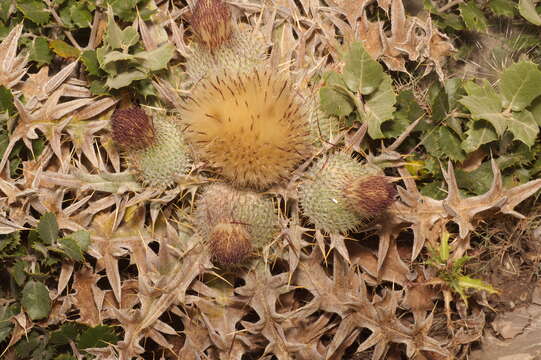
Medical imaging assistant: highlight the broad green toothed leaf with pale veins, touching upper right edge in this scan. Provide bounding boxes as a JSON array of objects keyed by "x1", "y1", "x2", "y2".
[{"x1": 499, "y1": 61, "x2": 541, "y2": 111}]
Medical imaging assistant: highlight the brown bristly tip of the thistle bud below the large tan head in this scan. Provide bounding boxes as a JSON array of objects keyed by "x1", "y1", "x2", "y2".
[{"x1": 209, "y1": 223, "x2": 252, "y2": 265}]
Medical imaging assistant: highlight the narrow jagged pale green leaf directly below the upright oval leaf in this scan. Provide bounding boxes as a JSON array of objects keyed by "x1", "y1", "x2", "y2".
[{"x1": 362, "y1": 74, "x2": 396, "y2": 139}]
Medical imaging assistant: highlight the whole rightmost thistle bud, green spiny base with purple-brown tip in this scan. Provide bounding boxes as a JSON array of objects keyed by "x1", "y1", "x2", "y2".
[{"x1": 299, "y1": 153, "x2": 396, "y2": 233}]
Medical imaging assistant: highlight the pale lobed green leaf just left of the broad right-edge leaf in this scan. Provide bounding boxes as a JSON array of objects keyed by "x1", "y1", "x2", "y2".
[{"x1": 459, "y1": 93, "x2": 507, "y2": 136}]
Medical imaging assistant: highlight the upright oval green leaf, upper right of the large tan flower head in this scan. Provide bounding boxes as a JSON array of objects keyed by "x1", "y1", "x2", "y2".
[{"x1": 344, "y1": 42, "x2": 383, "y2": 95}]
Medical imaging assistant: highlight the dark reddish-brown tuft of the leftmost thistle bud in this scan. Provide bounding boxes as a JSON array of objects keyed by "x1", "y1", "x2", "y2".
[{"x1": 111, "y1": 107, "x2": 155, "y2": 150}]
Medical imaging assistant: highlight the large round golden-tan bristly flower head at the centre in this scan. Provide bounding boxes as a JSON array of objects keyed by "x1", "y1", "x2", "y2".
[{"x1": 181, "y1": 70, "x2": 312, "y2": 189}]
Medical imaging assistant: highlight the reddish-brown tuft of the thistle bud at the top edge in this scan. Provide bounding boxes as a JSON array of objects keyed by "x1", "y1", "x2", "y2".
[{"x1": 191, "y1": 0, "x2": 232, "y2": 50}]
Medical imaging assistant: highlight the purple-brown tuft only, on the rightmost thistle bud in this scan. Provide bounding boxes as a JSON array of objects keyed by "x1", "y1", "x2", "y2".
[{"x1": 344, "y1": 176, "x2": 397, "y2": 217}]
